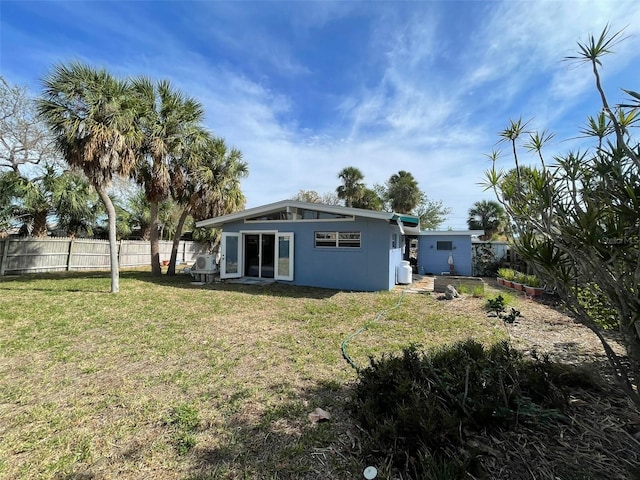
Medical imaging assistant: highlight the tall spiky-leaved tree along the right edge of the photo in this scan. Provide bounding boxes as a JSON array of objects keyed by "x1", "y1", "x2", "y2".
[{"x1": 486, "y1": 26, "x2": 640, "y2": 407}]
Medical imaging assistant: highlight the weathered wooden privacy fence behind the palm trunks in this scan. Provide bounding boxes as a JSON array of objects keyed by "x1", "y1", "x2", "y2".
[{"x1": 0, "y1": 238, "x2": 206, "y2": 275}]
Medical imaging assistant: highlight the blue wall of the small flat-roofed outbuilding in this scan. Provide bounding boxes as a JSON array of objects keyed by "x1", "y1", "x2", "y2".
[{"x1": 418, "y1": 233, "x2": 473, "y2": 276}]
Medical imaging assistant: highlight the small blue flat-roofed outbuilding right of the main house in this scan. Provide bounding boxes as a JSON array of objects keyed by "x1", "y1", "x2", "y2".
[{"x1": 418, "y1": 230, "x2": 484, "y2": 276}]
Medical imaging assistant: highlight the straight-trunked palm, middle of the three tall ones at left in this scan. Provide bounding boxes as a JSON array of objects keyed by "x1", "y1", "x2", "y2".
[{"x1": 133, "y1": 77, "x2": 204, "y2": 275}]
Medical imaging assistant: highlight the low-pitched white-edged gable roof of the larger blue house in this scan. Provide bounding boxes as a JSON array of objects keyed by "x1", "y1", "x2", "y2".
[{"x1": 196, "y1": 200, "x2": 420, "y2": 229}]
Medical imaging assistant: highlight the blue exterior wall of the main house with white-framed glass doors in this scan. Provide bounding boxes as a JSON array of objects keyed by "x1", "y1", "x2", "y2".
[{"x1": 223, "y1": 218, "x2": 401, "y2": 291}]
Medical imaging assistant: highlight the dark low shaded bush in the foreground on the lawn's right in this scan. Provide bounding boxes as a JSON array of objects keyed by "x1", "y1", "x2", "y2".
[{"x1": 350, "y1": 340, "x2": 567, "y2": 479}]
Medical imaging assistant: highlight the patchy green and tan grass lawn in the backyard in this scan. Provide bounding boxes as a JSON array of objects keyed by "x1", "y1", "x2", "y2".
[{"x1": 0, "y1": 272, "x2": 505, "y2": 480}]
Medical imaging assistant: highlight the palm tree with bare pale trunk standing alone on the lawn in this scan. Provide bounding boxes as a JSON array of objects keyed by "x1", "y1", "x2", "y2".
[{"x1": 37, "y1": 62, "x2": 140, "y2": 293}]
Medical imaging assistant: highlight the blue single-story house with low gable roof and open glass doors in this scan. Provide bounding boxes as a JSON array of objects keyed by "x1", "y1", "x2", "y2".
[{"x1": 196, "y1": 200, "x2": 420, "y2": 291}]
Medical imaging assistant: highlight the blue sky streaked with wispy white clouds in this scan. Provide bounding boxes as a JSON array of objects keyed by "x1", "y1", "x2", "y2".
[{"x1": 0, "y1": 0, "x2": 640, "y2": 229}]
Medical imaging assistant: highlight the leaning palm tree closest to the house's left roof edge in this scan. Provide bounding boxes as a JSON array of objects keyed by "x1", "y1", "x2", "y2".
[{"x1": 167, "y1": 136, "x2": 249, "y2": 275}]
